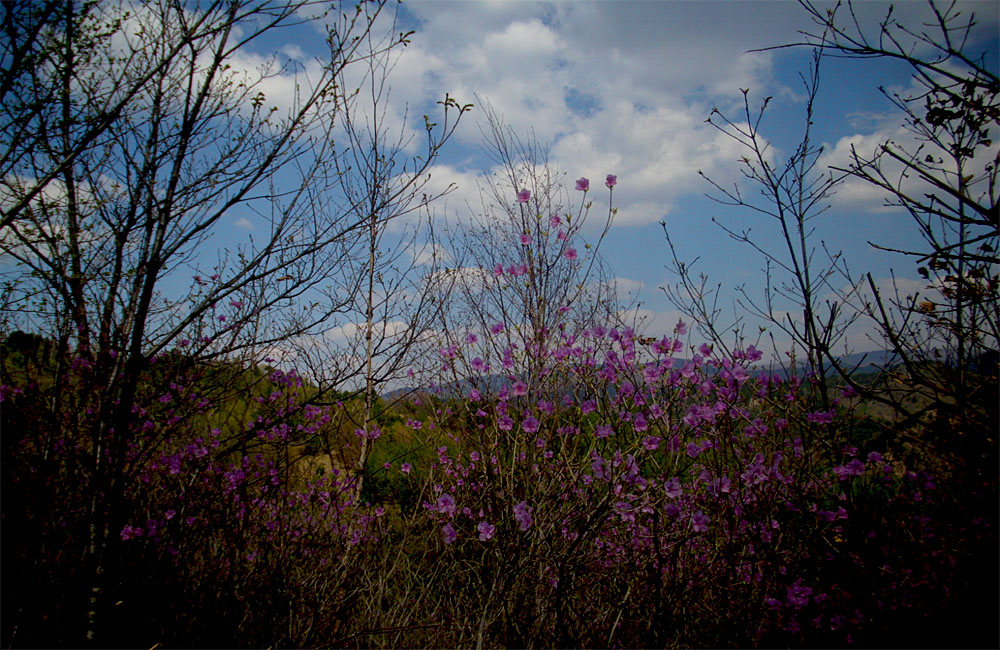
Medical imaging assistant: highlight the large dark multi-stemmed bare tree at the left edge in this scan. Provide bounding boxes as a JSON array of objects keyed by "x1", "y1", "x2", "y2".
[{"x1": 0, "y1": 1, "x2": 459, "y2": 639}]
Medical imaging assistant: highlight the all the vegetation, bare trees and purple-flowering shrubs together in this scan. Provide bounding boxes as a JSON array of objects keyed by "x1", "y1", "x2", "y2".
[{"x1": 0, "y1": 2, "x2": 1000, "y2": 648}]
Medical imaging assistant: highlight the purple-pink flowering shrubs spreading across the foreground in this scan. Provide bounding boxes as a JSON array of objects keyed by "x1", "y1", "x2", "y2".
[{"x1": 0, "y1": 176, "x2": 996, "y2": 647}]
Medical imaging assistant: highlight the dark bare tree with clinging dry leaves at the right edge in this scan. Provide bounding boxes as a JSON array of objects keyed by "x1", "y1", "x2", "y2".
[{"x1": 792, "y1": 1, "x2": 1000, "y2": 438}]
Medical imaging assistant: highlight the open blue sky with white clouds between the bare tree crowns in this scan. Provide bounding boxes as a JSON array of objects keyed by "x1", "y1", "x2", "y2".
[{"x1": 276, "y1": 0, "x2": 998, "y2": 347}]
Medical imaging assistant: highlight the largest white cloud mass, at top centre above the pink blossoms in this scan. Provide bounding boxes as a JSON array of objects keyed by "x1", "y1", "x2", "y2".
[{"x1": 376, "y1": 2, "x2": 820, "y2": 224}]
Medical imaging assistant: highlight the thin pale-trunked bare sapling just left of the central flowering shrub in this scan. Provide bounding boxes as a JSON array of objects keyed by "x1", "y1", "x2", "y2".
[{"x1": 324, "y1": 16, "x2": 472, "y2": 495}]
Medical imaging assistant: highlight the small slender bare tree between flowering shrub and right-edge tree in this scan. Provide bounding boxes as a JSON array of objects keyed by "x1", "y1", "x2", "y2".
[{"x1": 664, "y1": 44, "x2": 857, "y2": 407}]
